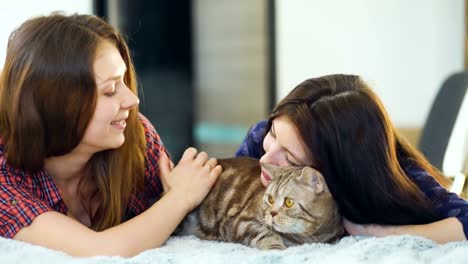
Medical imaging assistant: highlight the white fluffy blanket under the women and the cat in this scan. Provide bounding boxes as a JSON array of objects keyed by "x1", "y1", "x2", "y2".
[{"x1": 0, "y1": 236, "x2": 468, "y2": 264}]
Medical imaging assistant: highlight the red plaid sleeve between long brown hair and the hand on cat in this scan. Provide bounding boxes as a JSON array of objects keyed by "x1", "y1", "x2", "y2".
[{"x1": 140, "y1": 115, "x2": 166, "y2": 199}]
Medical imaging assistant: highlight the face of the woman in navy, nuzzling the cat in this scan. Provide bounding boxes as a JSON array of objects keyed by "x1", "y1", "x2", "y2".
[{"x1": 260, "y1": 116, "x2": 312, "y2": 186}]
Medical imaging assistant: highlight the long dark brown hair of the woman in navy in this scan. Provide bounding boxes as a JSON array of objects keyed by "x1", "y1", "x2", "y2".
[{"x1": 269, "y1": 75, "x2": 443, "y2": 224}]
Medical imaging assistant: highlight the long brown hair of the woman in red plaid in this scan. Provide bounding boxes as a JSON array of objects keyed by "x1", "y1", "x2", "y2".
[{"x1": 0, "y1": 13, "x2": 145, "y2": 230}]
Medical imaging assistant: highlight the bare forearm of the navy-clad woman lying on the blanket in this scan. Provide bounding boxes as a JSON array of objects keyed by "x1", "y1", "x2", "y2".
[{"x1": 343, "y1": 217, "x2": 466, "y2": 243}]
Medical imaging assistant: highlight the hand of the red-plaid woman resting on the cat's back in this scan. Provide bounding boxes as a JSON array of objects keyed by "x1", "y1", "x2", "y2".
[{"x1": 159, "y1": 148, "x2": 222, "y2": 211}]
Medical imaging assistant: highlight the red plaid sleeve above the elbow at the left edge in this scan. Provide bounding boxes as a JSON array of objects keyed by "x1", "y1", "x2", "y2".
[{"x1": 0, "y1": 183, "x2": 53, "y2": 238}]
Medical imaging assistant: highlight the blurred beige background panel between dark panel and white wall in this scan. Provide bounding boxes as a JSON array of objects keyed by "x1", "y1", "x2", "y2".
[{"x1": 193, "y1": 0, "x2": 273, "y2": 157}]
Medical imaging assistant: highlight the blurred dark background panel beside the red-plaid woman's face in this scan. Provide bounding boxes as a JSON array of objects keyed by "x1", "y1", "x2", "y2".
[{"x1": 103, "y1": 0, "x2": 197, "y2": 159}]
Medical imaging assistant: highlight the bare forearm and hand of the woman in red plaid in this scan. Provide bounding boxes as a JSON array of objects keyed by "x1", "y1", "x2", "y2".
[{"x1": 14, "y1": 148, "x2": 222, "y2": 257}]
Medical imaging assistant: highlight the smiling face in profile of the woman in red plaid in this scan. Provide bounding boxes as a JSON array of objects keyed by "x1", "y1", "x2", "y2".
[{"x1": 81, "y1": 41, "x2": 139, "y2": 152}]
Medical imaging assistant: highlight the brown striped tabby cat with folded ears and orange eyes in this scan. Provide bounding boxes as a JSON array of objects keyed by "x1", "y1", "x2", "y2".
[{"x1": 176, "y1": 157, "x2": 344, "y2": 249}]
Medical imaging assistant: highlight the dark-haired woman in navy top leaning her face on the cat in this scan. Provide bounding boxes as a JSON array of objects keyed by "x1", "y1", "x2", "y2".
[{"x1": 236, "y1": 75, "x2": 468, "y2": 242}]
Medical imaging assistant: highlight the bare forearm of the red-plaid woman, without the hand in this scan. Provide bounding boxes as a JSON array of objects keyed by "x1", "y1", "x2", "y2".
[{"x1": 14, "y1": 192, "x2": 189, "y2": 257}]
